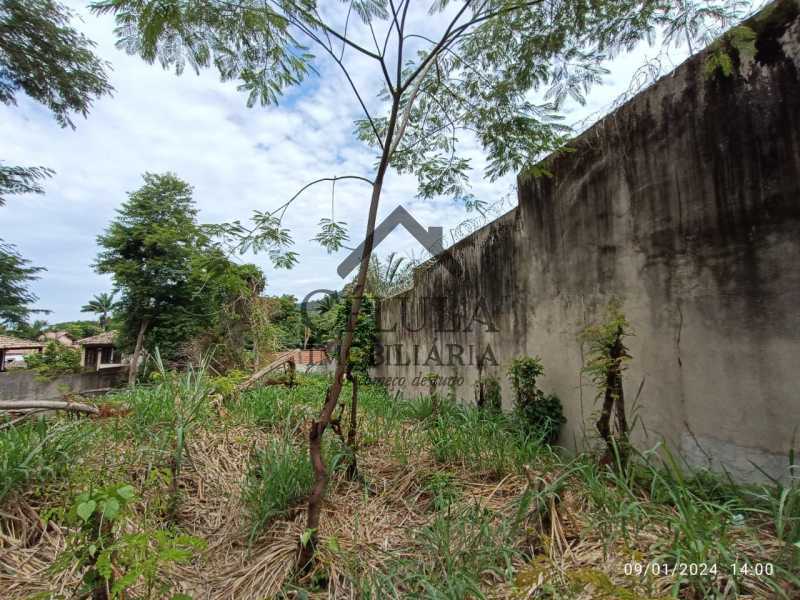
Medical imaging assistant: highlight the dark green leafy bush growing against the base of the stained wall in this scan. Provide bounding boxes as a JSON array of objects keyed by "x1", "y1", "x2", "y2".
[{"x1": 508, "y1": 356, "x2": 567, "y2": 444}]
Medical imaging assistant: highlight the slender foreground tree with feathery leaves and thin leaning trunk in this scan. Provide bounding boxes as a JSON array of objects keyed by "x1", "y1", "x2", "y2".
[{"x1": 94, "y1": 0, "x2": 752, "y2": 562}]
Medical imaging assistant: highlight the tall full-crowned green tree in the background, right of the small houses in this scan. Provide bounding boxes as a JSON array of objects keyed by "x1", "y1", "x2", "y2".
[{"x1": 95, "y1": 173, "x2": 263, "y2": 383}]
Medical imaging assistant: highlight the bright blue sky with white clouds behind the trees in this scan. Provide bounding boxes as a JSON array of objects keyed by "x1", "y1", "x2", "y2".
[{"x1": 0, "y1": 2, "x2": 712, "y2": 323}]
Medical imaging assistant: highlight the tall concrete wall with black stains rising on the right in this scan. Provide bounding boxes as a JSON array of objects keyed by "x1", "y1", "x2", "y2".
[{"x1": 375, "y1": 0, "x2": 800, "y2": 479}]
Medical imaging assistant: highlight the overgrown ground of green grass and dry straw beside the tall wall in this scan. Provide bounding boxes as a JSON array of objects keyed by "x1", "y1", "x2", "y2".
[{"x1": 0, "y1": 378, "x2": 800, "y2": 600}]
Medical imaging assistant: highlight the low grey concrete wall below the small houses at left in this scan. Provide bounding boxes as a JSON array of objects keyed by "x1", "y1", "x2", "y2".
[{"x1": 0, "y1": 368, "x2": 127, "y2": 400}]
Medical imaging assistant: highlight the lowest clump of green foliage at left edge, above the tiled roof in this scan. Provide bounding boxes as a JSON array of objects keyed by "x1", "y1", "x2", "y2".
[{"x1": 0, "y1": 240, "x2": 44, "y2": 326}]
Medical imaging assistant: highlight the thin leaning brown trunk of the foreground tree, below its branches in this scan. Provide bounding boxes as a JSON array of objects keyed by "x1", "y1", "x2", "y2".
[{"x1": 298, "y1": 96, "x2": 400, "y2": 568}]
